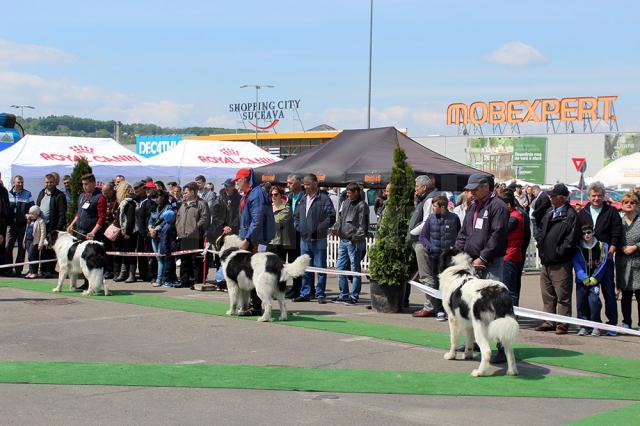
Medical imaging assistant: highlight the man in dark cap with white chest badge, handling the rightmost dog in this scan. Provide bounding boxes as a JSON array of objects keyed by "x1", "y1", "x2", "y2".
[{"x1": 456, "y1": 173, "x2": 509, "y2": 282}]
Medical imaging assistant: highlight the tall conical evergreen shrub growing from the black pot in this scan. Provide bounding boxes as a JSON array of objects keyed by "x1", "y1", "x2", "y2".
[{"x1": 369, "y1": 145, "x2": 415, "y2": 285}]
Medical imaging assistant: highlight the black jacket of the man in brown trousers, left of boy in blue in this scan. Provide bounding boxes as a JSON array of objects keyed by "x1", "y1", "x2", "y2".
[{"x1": 538, "y1": 203, "x2": 580, "y2": 266}]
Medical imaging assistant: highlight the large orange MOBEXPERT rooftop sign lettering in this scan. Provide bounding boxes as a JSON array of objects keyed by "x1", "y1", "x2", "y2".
[{"x1": 447, "y1": 96, "x2": 618, "y2": 126}]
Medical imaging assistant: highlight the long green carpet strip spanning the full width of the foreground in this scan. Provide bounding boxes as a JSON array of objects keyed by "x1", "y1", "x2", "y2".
[{"x1": 0, "y1": 361, "x2": 640, "y2": 401}]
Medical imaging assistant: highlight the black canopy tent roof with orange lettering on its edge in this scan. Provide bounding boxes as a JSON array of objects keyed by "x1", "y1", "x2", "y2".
[{"x1": 255, "y1": 127, "x2": 488, "y2": 191}]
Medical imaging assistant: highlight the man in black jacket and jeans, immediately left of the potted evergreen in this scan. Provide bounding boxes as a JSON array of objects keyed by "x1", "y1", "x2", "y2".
[{"x1": 335, "y1": 183, "x2": 369, "y2": 305}]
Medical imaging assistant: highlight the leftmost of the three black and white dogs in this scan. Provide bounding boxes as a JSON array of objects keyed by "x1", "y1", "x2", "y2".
[{"x1": 53, "y1": 232, "x2": 109, "y2": 296}]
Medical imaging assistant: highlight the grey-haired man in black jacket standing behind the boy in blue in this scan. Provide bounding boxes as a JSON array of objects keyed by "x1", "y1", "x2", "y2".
[{"x1": 578, "y1": 182, "x2": 623, "y2": 336}]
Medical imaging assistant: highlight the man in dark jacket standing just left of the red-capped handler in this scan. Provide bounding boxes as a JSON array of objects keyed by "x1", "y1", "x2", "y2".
[{"x1": 211, "y1": 179, "x2": 242, "y2": 289}]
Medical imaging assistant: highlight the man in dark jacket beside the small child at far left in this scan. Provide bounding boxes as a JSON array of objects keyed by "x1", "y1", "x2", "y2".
[{"x1": 36, "y1": 173, "x2": 67, "y2": 278}]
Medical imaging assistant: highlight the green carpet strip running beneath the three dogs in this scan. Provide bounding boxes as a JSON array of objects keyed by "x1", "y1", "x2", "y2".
[{"x1": 0, "y1": 280, "x2": 640, "y2": 378}]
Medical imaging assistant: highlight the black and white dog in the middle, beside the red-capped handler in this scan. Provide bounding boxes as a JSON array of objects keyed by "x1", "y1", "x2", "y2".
[{"x1": 217, "y1": 235, "x2": 309, "y2": 321}]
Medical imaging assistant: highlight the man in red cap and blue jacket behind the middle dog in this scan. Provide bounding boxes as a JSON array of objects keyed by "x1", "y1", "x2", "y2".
[{"x1": 233, "y1": 169, "x2": 276, "y2": 316}]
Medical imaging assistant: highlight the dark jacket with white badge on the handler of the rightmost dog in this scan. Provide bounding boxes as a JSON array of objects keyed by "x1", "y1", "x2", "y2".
[{"x1": 456, "y1": 193, "x2": 509, "y2": 263}]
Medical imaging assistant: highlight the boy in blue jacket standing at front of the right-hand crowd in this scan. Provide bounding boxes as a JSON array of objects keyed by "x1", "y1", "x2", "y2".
[{"x1": 573, "y1": 224, "x2": 609, "y2": 336}]
